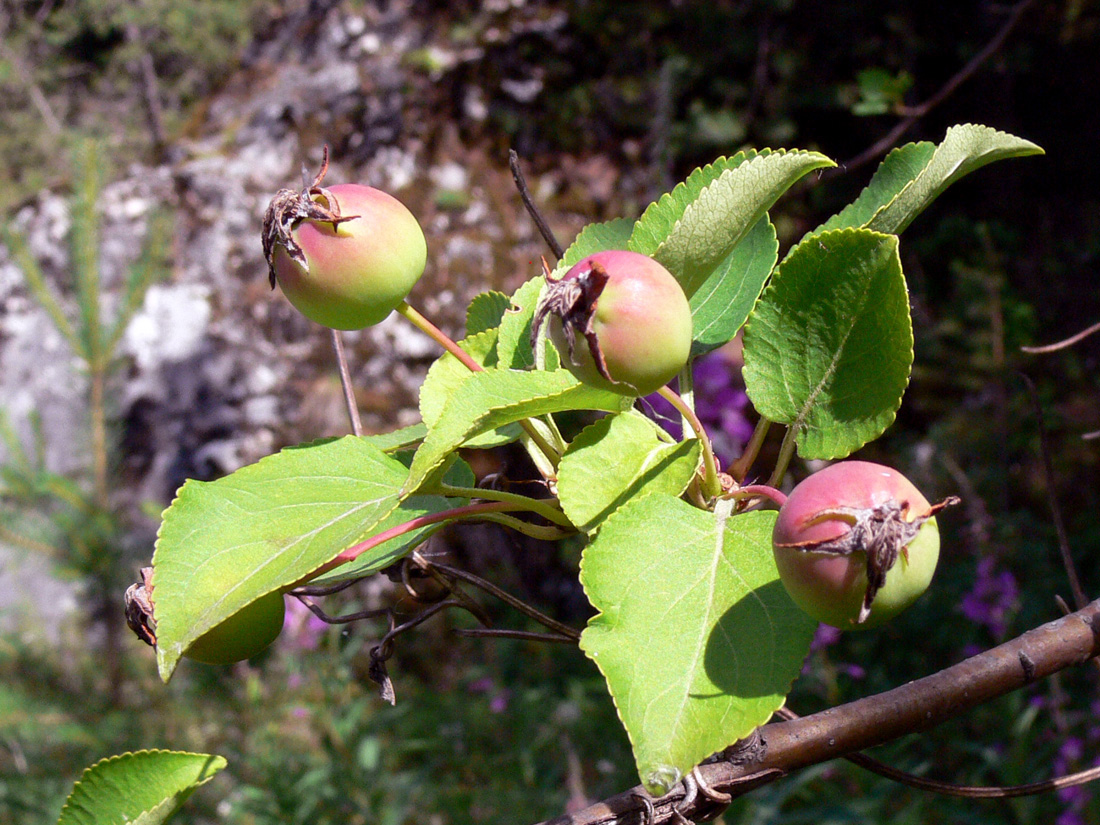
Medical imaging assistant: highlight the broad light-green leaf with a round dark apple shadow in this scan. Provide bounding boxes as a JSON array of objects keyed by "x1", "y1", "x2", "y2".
[{"x1": 581, "y1": 494, "x2": 816, "y2": 795}]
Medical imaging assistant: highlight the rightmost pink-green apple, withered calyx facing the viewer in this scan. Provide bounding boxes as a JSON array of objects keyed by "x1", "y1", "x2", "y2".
[{"x1": 772, "y1": 461, "x2": 958, "y2": 629}]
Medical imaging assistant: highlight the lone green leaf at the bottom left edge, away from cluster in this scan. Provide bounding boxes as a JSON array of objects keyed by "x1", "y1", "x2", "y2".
[{"x1": 57, "y1": 750, "x2": 226, "y2": 825}]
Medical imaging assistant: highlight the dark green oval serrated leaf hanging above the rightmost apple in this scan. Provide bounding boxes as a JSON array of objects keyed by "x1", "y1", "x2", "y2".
[{"x1": 743, "y1": 229, "x2": 913, "y2": 459}]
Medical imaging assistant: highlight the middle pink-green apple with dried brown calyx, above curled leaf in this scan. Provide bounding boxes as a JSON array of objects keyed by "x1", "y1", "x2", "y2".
[{"x1": 531, "y1": 250, "x2": 692, "y2": 395}]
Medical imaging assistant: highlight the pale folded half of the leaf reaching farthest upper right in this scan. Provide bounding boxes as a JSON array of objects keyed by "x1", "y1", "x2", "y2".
[{"x1": 864, "y1": 123, "x2": 1043, "y2": 234}]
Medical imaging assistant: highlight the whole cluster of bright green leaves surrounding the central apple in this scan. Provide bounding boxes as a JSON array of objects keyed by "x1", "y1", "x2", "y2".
[{"x1": 137, "y1": 125, "x2": 1041, "y2": 822}]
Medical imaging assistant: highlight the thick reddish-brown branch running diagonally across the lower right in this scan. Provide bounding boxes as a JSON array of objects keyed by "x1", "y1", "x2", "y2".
[{"x1": 545, "y1": 600, "x2": 1100, "y2": 825}]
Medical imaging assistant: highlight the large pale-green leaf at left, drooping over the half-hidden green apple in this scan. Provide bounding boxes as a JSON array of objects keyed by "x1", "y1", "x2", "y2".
[{"x1": 153, "y1": 436, "x2": 409, "y2": 680}]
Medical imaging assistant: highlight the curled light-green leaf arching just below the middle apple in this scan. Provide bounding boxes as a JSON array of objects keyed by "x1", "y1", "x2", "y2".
[{"x1": 403, "y1": 370, "x2": 633, "y2": 494}]
